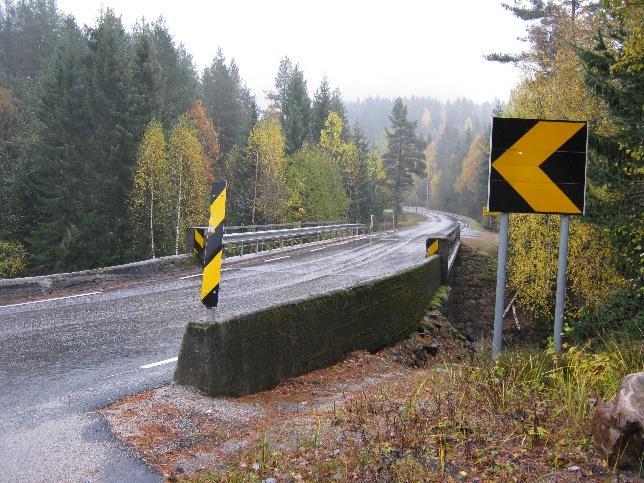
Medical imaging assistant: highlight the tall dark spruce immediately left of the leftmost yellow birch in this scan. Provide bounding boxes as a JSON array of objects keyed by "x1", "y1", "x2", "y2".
[{"x1": 85, "y1": 9, "x2": 138, "y2": 266}]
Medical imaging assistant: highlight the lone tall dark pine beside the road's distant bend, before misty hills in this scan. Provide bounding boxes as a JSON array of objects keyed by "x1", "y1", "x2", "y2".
[{"x1": 383, "y1": 97, "x2": 426, "y2": 218}]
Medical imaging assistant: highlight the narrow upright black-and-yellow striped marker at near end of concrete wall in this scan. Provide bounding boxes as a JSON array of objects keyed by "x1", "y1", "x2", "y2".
[{"x1": 201, "y1": 181, "x2": 226, "y2": 308}]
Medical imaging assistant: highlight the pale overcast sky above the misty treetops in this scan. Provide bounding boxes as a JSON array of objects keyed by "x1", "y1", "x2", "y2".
[{"x1": 58, "y1": 0, "x2": 525, "y2": 105}]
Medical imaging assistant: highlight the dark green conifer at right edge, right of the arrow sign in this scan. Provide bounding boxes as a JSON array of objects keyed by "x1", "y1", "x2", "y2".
[{"x1": 575, "y1": 0, "x2": 644, "y2": 282}]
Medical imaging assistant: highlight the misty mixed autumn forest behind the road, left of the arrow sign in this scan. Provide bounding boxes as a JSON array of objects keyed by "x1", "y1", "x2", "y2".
[{"x1": 0, "y1": 0, "x2": 490, "y2": 277}]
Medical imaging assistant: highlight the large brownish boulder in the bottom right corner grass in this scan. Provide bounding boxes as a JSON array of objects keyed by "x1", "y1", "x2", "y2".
[{"x1": 593, "y1": 372, "x2": 644, "y2": 471}]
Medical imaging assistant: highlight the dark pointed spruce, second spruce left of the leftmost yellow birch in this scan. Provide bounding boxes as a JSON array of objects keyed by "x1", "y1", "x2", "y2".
[{"x1": 27, "y1": 19, "x2": 91, "y2": 272}]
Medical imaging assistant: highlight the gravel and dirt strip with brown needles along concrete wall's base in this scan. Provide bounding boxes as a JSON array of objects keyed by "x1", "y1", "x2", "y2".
[{"x1": 101, "y1": 306, "x2": 473, "y2": 478}]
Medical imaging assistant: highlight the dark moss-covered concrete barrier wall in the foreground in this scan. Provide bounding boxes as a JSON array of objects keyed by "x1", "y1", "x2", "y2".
[{"x1": 175, "y1": 256, "x2": 441, "y2": 396}]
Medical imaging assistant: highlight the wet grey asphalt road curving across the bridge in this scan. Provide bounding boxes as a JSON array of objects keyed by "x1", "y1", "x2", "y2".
[{"x1": 0, "y1": 213, "x2": 451, "y2": 481}]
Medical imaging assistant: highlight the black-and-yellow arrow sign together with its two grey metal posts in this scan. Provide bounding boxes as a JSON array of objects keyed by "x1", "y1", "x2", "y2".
[{"x1": 487, "y1": 117, "x2": 588, "y2": 360}]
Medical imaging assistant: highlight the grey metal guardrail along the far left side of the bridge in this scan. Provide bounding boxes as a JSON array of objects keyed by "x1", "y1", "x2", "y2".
[{"x1": 186, "y1": 223, "x2": 367, "y2": 256}]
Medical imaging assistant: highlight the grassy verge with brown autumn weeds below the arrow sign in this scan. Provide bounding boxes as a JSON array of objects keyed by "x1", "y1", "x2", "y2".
[{"x1": 199, "y1": 343, "x2": 643, "y2": 482}]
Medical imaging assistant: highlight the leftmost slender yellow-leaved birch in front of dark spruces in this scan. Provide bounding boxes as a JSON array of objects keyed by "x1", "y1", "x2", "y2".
[{"x1": 128, "y1": 121, "x2": 172, "y2": 258}]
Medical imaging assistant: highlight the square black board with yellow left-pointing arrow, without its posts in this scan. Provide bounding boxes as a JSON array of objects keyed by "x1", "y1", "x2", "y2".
[{"x1": 488, "y1": 117, "x2": 588, "y2": 214}]
